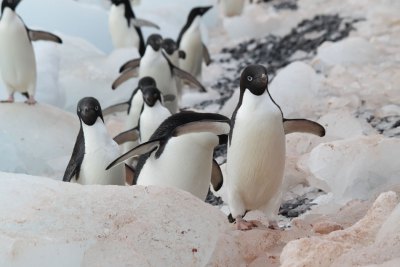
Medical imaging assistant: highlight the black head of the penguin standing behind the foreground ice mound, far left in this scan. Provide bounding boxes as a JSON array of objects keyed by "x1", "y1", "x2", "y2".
[{"x1": 76, "y1": 97, "x2": 104, "y2": 126}]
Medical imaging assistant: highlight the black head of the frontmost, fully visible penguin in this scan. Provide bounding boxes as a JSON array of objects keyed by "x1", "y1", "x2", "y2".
[{"x1": 240, "y1": 65, "x2": 268, "y2": 95}]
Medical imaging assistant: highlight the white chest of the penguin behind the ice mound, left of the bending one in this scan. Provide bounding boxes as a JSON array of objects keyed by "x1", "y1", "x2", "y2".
[{"x1": 77, "y1": 122, "x2": 125, "y2": 185}]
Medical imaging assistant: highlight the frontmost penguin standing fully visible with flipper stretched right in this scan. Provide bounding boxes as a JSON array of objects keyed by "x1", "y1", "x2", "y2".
[{"x1": 225, "y1": 65, "x2": 325, "y2": 230}]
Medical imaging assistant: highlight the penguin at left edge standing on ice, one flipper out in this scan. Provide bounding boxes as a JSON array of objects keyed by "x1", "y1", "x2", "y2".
[{"x1": 0, "y1": 0, "x2": 62, "y2": 105}]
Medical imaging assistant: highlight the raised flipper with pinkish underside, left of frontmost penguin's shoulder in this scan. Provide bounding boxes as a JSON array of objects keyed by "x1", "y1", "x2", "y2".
[{"x1": 172, "y1": 119, "x2": 230, "y2": 136}]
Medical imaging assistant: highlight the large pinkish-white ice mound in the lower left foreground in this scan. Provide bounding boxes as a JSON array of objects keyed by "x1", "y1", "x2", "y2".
[{"x1": 0, "y1": 173, "x2": 231, "y2": 266}]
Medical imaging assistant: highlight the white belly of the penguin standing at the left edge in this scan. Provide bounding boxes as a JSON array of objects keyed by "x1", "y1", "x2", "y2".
[{"x1": 0, "y1": 12, "x2": 36, "y2": 94}]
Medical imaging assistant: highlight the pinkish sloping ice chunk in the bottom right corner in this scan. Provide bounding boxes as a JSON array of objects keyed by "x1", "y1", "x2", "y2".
[{"x1": 280, "y1": 192, "x2": 400, "y2": 267}]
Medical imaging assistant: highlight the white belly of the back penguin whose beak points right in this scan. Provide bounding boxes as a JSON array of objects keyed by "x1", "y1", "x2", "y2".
[{"x1": 179, "y1": 29, "x2": 203, "y2": 79}]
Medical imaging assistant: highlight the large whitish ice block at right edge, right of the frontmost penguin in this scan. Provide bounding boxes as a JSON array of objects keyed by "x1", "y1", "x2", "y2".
[{"x1": 299, "y1": 135, "x2": 400, "y2": 203}]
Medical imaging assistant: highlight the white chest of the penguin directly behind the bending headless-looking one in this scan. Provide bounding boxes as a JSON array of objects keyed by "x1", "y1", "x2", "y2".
[{"x1": 140, "y1": 102, "x2": 171, "y2": 143}]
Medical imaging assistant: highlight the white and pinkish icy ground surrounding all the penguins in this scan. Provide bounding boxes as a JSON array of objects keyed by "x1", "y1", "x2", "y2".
[{"x1": 0, "y1": 0, "x2": 400, "y2": 266}]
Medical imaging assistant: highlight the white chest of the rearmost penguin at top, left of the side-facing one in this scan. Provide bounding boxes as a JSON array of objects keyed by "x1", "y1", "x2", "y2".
[{"x1": 108, "y1": 5, "x2": 140, "y2": 48}]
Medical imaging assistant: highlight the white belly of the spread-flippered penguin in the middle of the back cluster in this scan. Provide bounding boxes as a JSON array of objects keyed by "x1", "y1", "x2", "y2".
[{"x1": 139, "y1": 54, "x2": 178, "y2": 113}]
